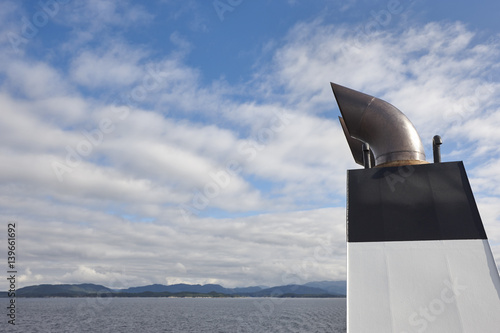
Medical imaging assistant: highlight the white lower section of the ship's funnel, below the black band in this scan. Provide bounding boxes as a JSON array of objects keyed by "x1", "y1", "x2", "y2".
[{"x1": 347, "y1": 240, "x2": 500, "y2": 333}]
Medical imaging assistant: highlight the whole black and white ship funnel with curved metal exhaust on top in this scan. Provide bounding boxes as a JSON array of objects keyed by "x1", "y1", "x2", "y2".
[{"x1": 331, "y1": 83, "x2": 500, "y2": 333}]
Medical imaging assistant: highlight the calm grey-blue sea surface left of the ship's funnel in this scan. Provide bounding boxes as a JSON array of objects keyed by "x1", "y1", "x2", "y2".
[{"x1": 5, "y1": 298, "x2": 346, "y2": 333}]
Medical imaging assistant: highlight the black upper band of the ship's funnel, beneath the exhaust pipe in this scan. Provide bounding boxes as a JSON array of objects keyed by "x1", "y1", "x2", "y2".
[{"x1": 347, "y1": 162, "x2": 486, "y2": 242}]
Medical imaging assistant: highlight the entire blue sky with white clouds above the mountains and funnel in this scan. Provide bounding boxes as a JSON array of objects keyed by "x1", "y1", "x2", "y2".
[{"x1": 0, "y1": 0, "x2": 500, "y2": 290}]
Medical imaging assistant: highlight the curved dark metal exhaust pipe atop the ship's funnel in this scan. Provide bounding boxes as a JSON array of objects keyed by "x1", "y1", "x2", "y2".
[{"x1": 331, "y1": 83, "x2": 427, "y2": 166}]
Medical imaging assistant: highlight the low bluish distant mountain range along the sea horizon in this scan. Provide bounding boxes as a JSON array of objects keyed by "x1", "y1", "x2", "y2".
[{"x1": 9, "y1": 281, "x2": 346, "y2": 297}]
